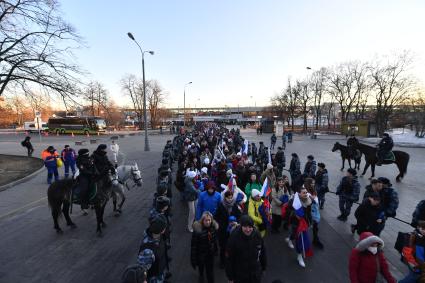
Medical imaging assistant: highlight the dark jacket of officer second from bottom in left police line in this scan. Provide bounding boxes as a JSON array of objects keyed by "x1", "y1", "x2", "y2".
[{"x1": 139, "y1": 229, "x2": 167, "y2": 282}]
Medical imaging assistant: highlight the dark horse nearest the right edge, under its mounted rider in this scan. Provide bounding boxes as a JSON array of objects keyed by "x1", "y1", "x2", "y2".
[{"x1": 357, "y1": 143, "x2": 410, "y2": 182}]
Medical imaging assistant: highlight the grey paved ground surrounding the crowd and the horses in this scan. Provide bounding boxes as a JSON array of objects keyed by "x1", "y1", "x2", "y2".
[{"x1": 0, "y1": 130, "x2": 425, "y2": 283}]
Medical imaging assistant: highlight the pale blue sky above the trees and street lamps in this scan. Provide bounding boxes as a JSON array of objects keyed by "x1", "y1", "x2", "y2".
[{"x1": 61, "y1": 0, "x2": 425, "y2": 107}]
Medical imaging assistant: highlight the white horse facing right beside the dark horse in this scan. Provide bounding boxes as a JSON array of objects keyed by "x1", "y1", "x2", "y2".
[{"x1": 112, "y1": 163, "x2": 143, "y2": 216}]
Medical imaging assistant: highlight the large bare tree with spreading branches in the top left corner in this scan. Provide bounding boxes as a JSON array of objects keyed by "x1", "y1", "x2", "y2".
[{"x1": 0, "y1": 0, "x2": 82, "y2": 100}]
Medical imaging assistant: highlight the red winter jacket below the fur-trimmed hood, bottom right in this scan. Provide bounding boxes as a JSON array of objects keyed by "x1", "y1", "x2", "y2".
[{"x1": 349, "y1": 246, "x2": 396, "y2": 283}]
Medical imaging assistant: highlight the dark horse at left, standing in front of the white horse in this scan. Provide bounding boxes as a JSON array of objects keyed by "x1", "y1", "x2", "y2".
[{"x1": 47, "y1": 179, "x2": 112, "y2": 236}]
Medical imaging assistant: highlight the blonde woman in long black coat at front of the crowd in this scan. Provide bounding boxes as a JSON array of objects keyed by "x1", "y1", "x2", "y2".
[{"x1": 190, "y1": 211, "x2": 218, "y2": 283}]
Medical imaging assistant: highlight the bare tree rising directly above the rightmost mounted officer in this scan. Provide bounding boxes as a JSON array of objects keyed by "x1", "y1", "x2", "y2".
[{"x1": 369, "y1": 52, "x2": 415, "y2": 138}]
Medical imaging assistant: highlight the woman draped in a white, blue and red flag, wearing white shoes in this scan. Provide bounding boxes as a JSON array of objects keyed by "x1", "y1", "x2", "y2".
[{"x1": 285, "y1": 187, "x2": 313, "y2": 267}]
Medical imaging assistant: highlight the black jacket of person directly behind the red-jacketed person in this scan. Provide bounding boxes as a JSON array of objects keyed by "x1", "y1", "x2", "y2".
[{"x1": 354, "y1": 200, "x2": 382, "y2": 235}]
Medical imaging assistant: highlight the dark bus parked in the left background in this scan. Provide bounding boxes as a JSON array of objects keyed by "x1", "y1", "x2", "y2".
[{"x1": 47, "y1": 116, "x2": 106, "y2": 135}]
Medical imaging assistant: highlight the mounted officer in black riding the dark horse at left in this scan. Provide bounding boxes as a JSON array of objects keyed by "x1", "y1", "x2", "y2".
[{"x1": 77, "y1": 148, "x2": 96, "y2": 209}]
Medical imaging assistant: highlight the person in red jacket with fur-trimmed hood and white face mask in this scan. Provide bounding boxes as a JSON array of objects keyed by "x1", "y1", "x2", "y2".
[{"x1": 349, "y1": 232, "x2": 394, "y2": 283}]
